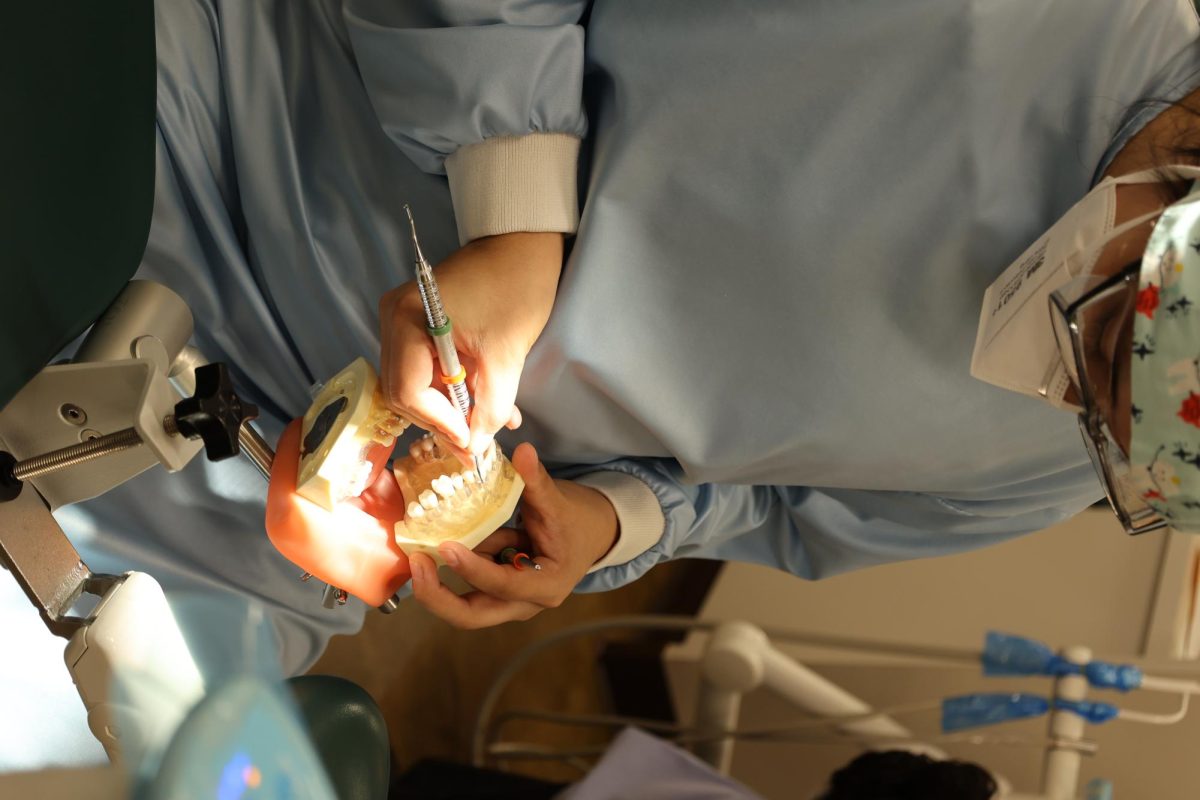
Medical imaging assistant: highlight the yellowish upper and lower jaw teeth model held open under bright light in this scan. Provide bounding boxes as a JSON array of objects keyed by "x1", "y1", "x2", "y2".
[{"x1": 296, "y1": 359, "x2": 524, "y2": 564}]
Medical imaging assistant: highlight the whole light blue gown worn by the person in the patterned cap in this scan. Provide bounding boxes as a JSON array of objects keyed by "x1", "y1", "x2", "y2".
[{"x1": 11, "y1": 0, "x2": 1200, "y2": 767}]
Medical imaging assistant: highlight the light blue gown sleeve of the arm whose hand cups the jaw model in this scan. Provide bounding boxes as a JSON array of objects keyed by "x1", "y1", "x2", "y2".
[{"x1": 566, "y1": 459, "x2": 1098, "y2": 591}]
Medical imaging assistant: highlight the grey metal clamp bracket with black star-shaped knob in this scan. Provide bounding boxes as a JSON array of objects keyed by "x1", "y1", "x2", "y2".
[{"x1": 0, "y1": 281, "x2": 270, "y2": 638}]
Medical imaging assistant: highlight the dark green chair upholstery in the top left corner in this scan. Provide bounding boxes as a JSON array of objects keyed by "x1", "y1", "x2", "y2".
[{"x1": 0, "y1": 6, "x2": 157, "y2": 417}]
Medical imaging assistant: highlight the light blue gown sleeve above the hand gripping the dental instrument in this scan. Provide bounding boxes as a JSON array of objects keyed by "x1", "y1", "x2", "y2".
[{"x1": 343, "y1": 0, "x2": 587, "y2": 174}]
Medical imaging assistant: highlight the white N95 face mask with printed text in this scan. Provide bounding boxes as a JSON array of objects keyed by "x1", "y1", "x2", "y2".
[{"x1": 971, "y1": 169, "x2": 1175, "y2": 408}]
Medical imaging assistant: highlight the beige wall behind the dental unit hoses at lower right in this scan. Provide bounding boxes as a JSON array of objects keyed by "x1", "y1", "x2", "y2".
[{"x1": 667, "y1": 511, "x2": 1200, "y2": 800}]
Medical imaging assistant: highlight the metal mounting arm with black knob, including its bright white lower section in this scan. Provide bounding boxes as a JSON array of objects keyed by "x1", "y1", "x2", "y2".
[{"x1": 0, "y1": 281, "x2": 269, "y2": 760}]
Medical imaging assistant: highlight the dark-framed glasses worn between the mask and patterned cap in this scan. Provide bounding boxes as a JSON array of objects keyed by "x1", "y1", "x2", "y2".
[{"x1": 1050, "y1": 261, "x2": 1166, "y2": 535}]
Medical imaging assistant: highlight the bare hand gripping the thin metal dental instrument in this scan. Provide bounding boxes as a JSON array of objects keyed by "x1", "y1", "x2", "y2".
[{"x1": 379, "y1": 233, "x2": 563, "y2": 458}]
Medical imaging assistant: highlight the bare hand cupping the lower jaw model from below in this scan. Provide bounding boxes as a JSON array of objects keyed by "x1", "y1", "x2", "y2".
[{"x1": 409, "y1": 444, "x2": 618, "y2": 628}]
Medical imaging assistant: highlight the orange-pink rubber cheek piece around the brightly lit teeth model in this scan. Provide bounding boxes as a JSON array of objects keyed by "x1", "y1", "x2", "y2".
[{"x1": 266, "y1": 420, "x2": 409, "y2": 606}]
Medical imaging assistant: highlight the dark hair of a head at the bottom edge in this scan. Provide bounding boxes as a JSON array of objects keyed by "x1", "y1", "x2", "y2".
[{"x1": 820, "y1": 750, "x2": 996, "y2": 800}]
